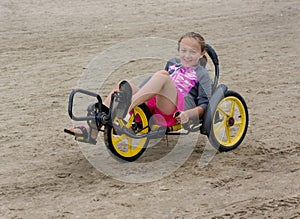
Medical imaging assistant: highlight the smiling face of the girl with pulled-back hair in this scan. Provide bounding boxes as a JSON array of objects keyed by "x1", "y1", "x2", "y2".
[{"x1": 179, "y1": 37, "x2": 204, "y2": 67}]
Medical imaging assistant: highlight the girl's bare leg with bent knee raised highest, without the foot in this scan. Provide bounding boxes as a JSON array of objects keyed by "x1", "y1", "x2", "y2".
[{"x1": 129, "y1": 70, "x2": 177, "y2": 115}]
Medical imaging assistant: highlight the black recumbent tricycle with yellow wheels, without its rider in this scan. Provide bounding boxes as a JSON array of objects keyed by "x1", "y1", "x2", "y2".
[{"x1": 68, "y1": 44, "x2": 249, "y2": 162}]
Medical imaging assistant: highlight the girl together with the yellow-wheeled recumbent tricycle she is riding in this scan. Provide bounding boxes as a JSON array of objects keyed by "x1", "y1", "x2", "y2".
[{"x1": 65, "y1": 32, "x2": 249, "y2": 161}]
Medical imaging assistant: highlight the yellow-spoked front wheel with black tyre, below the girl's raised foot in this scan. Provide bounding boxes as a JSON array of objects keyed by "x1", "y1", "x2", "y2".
[{"x1": 104, "y1": 104, "x2": 150, "y2": 161}]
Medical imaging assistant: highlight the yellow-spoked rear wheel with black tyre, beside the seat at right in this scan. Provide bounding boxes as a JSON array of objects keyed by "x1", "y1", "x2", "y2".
[{"x1": 210, "y1": 91, "x2": 249, "y2": 151}]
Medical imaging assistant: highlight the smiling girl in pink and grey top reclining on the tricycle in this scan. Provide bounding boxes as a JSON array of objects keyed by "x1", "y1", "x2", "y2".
[{"x1": 69, "y1": 32, "x2": 211, "y2": 144}]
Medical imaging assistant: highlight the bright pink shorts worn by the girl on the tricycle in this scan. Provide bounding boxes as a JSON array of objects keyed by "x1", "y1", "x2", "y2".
[{"x1": 147, "y1": 92, "x2": 184, "y2": 126}]
